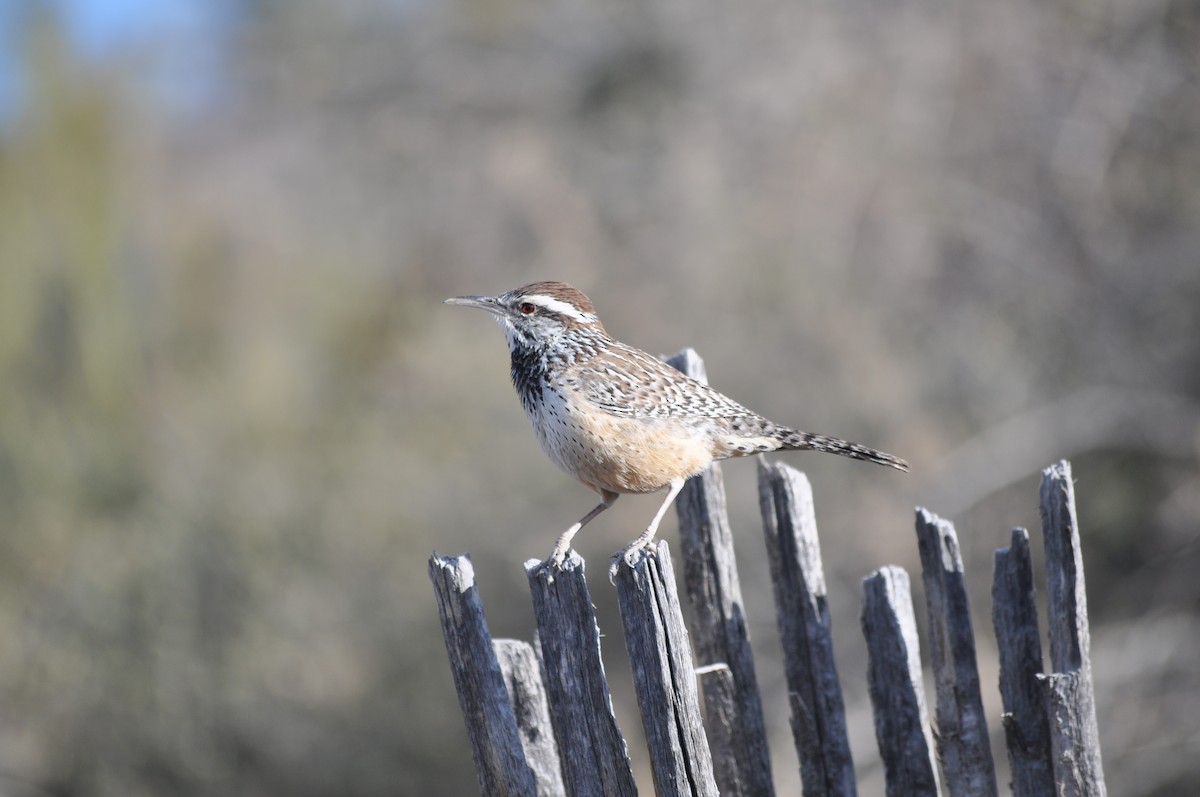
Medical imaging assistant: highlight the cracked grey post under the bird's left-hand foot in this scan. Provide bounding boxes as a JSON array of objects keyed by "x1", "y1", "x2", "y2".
[{"x1": 526, "y1": 551, "x2": 637, "y2": 797}]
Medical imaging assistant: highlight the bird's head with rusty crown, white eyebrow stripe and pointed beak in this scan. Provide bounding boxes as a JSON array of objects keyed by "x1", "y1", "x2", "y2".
[{"x1": 445, "y1": 282, "x2": 604, "y2": 349}]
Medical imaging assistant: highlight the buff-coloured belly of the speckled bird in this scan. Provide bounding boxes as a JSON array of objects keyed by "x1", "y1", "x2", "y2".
[{"x1": 530, "y1": 390, "x2": 713, "y2": 492}]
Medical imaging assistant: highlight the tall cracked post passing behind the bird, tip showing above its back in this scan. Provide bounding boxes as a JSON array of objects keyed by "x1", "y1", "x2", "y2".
[{"x1": 667, "y1": 348, "x2": 775, "y2": 797}]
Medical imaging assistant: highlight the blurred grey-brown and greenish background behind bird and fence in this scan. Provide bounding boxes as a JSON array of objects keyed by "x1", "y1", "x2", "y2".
[{"x1": 0, "y1": 0, "x2": 1200, "y2": 797}]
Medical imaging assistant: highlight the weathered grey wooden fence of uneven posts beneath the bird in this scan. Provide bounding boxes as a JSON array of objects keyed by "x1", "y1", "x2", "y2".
[{"x1": 430, "y1": 350, "x2": 1105, "y2": 797}]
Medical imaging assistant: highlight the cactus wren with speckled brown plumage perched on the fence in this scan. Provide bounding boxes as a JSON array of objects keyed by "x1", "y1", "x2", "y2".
[{"x1": 446, "y1": 282, "x2": 908, "y2": 573}]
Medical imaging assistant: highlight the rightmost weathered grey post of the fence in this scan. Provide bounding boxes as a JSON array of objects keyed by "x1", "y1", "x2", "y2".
[{"x1": 1040, "y1": 460, "x2": 1105, "y2": 797}]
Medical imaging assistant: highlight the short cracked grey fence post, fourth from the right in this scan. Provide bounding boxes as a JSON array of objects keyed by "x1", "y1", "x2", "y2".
[{"x1": 863, "y1": 567, "x2": 941, "y2": 797}]
